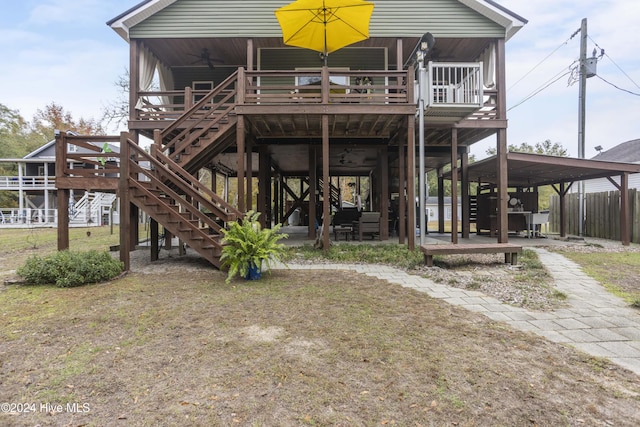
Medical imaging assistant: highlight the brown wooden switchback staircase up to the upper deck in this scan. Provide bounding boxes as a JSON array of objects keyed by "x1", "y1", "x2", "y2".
[{"x1": 121, "y1": 74, "x2": 243, "y2": 268}]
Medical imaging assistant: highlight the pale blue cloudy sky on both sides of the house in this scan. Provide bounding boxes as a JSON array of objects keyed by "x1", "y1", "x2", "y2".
[{"x1": 0, "y1": 0, "x2": 640, "y2": 159}]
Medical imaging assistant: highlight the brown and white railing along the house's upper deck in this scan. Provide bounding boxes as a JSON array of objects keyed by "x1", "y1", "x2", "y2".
[{"x1": 135, "y1": 62, "x2": 496, "y2": 121}]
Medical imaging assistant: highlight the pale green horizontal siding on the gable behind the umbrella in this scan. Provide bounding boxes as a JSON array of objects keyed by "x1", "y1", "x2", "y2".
[{"x1": 131, "y1": 0, "x2": 505, "y2": 38}]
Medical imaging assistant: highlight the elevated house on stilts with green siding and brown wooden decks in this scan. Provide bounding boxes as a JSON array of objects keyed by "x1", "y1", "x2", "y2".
[{"x1": 56, "y1": 0, "x2": 526, "y2": 268}]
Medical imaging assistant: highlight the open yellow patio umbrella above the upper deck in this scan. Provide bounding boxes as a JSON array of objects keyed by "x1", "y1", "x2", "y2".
[{"x1": 275, "y1": 0, "x2": 373, "y2": 65}]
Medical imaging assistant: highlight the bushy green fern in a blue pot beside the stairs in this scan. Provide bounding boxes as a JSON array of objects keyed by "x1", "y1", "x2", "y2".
[{"x1": 220, "y1": 211, "x2": 288, "y2": 283}]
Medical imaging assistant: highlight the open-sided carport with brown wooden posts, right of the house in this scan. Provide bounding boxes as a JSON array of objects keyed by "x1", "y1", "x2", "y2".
[{"x1": 447, "y1": 152, "x2": 640, "y2": 245}]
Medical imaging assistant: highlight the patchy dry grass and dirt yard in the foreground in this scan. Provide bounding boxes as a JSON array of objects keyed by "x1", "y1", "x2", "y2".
[{"x1": 0, "y1": 244, "x2": 640, "y2": 427}]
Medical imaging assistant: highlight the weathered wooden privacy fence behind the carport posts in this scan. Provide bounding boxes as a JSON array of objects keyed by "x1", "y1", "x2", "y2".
[{"x1": 549, "y1": 188, "x2": 640, "y2": 243}]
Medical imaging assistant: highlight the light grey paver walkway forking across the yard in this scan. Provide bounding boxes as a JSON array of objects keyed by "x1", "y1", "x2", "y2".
[{"x1": 275, "y1": 248, "x2": 640, "y2": 375}]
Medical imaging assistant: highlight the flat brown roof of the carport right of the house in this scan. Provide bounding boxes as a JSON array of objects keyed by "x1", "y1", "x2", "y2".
[{"x1": 445, "y1": 152, "x2": 640, "y2": 188}]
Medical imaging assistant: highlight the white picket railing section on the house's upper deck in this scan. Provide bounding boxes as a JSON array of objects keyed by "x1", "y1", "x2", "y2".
[{"x1": 425, "y1": 62, "x2": 484, "y2": 108}]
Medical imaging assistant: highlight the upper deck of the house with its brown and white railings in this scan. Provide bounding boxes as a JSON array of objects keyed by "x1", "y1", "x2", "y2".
[{"x1": 129, "y1": 62, "x2": 504, "y2": 145}]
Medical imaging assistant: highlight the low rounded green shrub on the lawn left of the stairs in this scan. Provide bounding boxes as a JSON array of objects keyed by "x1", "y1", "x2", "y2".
[{"x1": 17, "y1": 250, "x2": 124, "y2": 288}]
